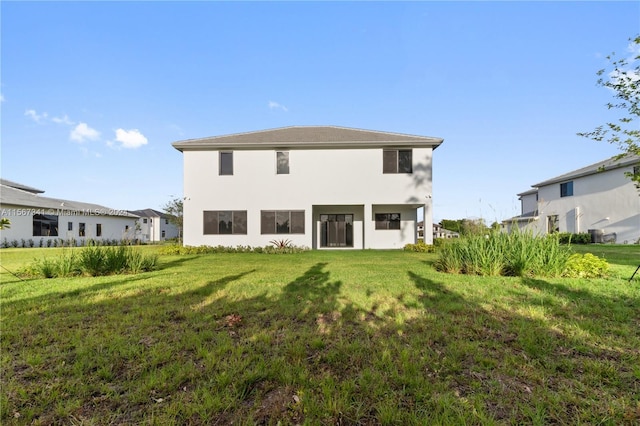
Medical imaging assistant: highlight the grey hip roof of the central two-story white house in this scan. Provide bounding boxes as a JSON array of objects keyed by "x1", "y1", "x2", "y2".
[{"x1": 172, "y1": 126, "x2": 443, "y2": 152}]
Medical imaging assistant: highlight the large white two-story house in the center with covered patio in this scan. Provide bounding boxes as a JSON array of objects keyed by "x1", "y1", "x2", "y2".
[{"x1": 173, "y1": 126, "x2": 443, "y2": 249}]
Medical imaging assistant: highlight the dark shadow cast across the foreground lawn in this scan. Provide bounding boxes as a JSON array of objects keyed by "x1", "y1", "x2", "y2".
[{"x1": 5, "y1": 262, "x2": 640, "y2": 424}]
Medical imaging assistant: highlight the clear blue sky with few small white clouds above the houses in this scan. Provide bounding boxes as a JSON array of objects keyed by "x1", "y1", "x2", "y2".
[{"x1": 0, "y1": 1, "x2": 640, "y2": 222}]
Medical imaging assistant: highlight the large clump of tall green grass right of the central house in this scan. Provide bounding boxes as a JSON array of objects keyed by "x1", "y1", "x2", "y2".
[{"x1": 435, "y1": 232, "x2": 572, "y2": 277}]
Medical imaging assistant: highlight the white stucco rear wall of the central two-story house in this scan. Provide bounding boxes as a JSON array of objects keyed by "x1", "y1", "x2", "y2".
[{"x1": 183, "y1": 148, "x2": 432, "y2": 248}]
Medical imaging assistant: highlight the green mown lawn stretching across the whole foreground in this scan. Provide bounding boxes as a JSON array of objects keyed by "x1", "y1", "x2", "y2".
[{"x1": 0, "y1": 245, "x2": 640, "y2": 425}]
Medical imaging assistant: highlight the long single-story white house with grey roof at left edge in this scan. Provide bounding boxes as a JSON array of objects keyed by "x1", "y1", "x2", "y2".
[{"x1": 0, "y1": 179, "x2": 138, "y2": 245}]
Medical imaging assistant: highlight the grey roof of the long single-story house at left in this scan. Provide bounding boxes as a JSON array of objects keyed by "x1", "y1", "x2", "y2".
[{"x1": 0, "y1": 180, "x2": 137, "y2": 218}]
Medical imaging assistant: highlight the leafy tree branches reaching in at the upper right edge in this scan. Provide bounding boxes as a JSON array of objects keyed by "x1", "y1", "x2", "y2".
[{"x1": 578, "y1": 35, "x2": 640, "y2": 186}]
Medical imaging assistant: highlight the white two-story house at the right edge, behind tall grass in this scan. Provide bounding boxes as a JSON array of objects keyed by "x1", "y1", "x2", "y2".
[{"x1": 502, "y1": 156, "x2": 640, "y2": 244}]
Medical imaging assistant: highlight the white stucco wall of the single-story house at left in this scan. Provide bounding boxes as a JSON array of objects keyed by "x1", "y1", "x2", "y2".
[{"x1": 0, "y1": 205, "x2": 135, "y2": 246}]
